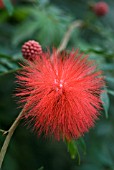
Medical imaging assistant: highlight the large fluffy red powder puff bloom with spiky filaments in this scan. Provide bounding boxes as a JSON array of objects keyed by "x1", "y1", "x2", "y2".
[{"x1": 16, "y1": 50, "x2": 104, "y2": 140}]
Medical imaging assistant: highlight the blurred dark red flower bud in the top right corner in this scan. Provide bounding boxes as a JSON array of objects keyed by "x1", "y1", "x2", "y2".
[{"x1": 93, "y1": 2, "x2": 109, "y2": 16}]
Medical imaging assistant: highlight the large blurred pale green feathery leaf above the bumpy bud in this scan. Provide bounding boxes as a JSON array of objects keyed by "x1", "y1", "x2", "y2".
[{"x1": 13, "y1": 6, "x2": 72, "y2": 46}]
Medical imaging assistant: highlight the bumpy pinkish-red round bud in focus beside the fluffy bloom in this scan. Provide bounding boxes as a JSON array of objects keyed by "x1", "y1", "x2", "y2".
[{"x1": 22, "y1": 40, "x2": 42, "y2": 61}]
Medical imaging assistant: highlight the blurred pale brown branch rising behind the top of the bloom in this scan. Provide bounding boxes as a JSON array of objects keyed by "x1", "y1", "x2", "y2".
[{"x1": 57, "y1": 20, "x2": 84, "y2": 52}]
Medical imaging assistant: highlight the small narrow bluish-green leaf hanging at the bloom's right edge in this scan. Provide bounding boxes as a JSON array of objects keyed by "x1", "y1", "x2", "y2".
[{"x1": 101, "y1": 89, "x2": 110, "y2": 118}]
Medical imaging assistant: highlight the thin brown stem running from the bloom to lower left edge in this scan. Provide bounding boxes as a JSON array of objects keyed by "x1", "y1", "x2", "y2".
[{"x1": 0, "y1": 109, "x2": 24, "y2": 169}]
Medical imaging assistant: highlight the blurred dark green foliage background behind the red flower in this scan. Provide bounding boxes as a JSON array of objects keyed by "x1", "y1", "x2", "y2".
[{"x1": 0, "y1": 0, "x2": 114, "y2": 170}]
